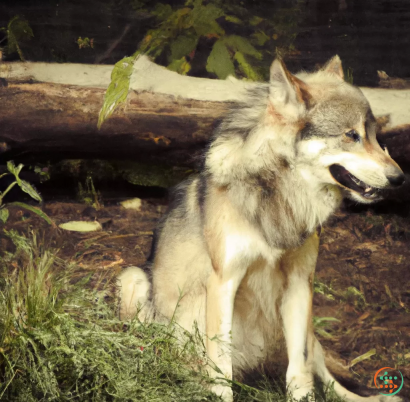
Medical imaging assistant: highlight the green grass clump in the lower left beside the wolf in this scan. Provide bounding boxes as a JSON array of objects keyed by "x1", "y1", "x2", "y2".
[{"x1": 0, "y1": 232, "x2": 219, "y2": 402}]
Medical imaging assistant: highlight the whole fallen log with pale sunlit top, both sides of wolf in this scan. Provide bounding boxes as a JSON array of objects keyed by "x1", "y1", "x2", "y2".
[{"x1": 0, "y1": 57, "x2": 410, "y2": 166}]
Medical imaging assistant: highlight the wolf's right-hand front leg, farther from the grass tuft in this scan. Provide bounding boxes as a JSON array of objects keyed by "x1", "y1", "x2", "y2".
[{"x1": 280, "y1": 234, "x2": 319, "y2": 400}]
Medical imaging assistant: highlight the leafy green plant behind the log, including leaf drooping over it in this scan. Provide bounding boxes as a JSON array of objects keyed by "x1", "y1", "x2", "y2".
[{"x1": 98, "y1": 0, "x2": 304, "y2": 127}]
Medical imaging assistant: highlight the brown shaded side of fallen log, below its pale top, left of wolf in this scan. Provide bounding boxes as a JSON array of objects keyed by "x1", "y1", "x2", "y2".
[{"x1": 0, "y1": 83, "x2": 228, "y2": 166}]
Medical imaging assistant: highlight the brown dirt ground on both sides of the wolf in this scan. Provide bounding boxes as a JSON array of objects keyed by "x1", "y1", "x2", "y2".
[{"x1": 0, "y1": 188, "x2": 410, "y2": 396}]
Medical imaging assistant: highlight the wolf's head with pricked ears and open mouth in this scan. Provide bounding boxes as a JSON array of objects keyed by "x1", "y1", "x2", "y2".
[{"x1": 268, "y1": 56, "x2": 404, "y2": 203}]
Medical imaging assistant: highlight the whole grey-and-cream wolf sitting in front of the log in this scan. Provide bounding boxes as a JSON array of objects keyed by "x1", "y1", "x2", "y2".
[{"x1": 118, "y1": 56, "x2": 404, "y2": 402}]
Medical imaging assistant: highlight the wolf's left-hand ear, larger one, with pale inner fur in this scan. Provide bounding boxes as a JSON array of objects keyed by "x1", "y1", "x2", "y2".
[{"x1": 270, "y1": 59, "x2": 304, "y2": 105}]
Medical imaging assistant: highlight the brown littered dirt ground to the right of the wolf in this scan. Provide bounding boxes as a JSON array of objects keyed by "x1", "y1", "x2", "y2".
[{"x1": 314, "y1": 206, "x2": 410, "y2": 397}]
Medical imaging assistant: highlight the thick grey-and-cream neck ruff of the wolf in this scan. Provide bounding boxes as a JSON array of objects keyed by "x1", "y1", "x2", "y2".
[{"x1": 205, "y1": 84, "x2": 342, "y2": 249}]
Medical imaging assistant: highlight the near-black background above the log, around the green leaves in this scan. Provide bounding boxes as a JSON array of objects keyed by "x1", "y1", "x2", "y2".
[{"x1": 0, "y1": 0, "x2": 410, "y2": 86}]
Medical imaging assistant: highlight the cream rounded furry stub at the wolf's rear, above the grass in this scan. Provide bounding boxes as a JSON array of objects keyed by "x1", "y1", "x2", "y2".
[{"x1": 117, "y1": 267, "x2": 153, "y2": 321}]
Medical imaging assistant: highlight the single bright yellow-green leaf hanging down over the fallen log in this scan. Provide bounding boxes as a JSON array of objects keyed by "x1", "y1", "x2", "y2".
[{"x1": 97, "y1": 52, "x2": 138, "y2": 129}]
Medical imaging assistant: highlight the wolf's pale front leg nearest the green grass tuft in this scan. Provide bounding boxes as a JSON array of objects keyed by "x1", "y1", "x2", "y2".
[{"x1": 206, "y1": 270, "x2": 248, "y2": 402}]
